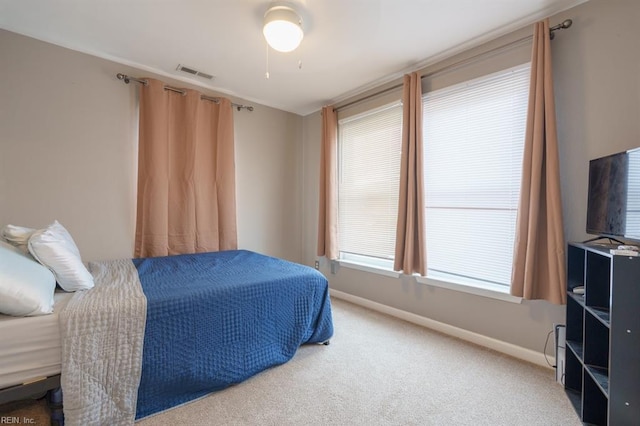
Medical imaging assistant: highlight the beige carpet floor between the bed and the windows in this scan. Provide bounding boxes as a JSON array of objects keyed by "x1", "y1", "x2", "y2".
[{"x1": 0, "y1": 299, "x2": 581, "y2": 426}]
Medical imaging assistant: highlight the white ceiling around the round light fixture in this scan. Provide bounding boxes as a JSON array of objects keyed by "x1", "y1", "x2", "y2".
[{"x1": 0, "y1": 0, "x2": 586, "y2": 115}]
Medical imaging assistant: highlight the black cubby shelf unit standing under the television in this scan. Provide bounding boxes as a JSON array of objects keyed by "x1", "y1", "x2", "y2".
[{"x1": 564, "y1": 243, "x2": 640, "y2": 425}]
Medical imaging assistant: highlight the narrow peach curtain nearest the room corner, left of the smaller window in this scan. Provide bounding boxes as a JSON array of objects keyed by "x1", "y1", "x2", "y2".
[{"x1": 317, "y1": 106, "x2": 338, "y2": 260}]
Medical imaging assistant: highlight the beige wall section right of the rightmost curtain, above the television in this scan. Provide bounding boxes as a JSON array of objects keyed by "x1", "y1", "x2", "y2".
[{"x1": 553, "y1": 0, "x2": 640, "y2": 241}]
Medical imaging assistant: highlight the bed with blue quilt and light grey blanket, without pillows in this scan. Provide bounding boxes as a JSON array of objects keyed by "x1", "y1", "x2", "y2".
[{"x1": 0, "y1": 243, "x2": 333, "y2": 425}]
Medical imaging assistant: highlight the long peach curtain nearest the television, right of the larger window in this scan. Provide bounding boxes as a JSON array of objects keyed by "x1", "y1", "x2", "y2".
[{"x1": 511, "y1": 19, "x2": 566, "y2": 304}]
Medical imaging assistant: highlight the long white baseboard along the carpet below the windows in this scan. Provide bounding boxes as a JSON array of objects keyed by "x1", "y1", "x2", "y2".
[{"x1": 329, "y1": 289, "x2": 555, "y2": 369}]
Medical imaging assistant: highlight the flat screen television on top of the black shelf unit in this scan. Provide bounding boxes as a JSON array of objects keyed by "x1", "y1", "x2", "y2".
[{"x1": 587, "y1": 148, "x2": 640, "y2": 241}]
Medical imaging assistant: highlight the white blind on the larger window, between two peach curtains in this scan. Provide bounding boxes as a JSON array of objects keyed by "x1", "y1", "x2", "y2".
[{"x1": 423, "y1": 64, "x2": 530, "y2": 287}]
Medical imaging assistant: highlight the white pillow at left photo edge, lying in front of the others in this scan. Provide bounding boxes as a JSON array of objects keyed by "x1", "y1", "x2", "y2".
[{"x1": 0, "y1": 241, "x2": 56, "y2": 316}]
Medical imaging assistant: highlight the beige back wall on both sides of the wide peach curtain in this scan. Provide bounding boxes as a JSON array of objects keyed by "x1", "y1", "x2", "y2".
[{"x1": 0, "y1": 30, "x2": 302, "y2": 261}]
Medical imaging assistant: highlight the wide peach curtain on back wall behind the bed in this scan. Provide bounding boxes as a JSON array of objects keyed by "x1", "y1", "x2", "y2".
[{"x1": 134, "y1": 79, "x2": 237, "y2": 257}]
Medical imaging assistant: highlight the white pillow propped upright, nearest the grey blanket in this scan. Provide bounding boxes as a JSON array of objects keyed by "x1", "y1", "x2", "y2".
[{"x1": 28, "y1": 220, "x2": 93, "y2": 291}]
